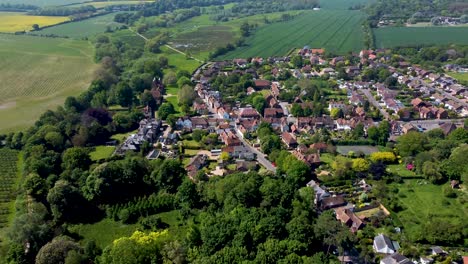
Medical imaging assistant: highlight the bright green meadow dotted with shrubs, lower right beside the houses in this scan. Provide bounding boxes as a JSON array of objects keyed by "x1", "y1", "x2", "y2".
[{"x1": 397, "y1": 180, "x2": 468, "y2": 242}]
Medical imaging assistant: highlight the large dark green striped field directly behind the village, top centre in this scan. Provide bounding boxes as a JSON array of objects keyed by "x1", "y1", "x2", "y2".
[{"x1": 221, "y1": 10, "x2": 365, "y2": 59}]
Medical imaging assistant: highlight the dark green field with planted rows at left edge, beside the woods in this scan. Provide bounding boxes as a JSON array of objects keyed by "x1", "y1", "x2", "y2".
[{"x1": 0, "y1": 149, "x2": 18, "y2": 228}]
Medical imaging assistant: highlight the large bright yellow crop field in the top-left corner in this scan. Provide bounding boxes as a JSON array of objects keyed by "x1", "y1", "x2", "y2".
[{"x1": 0, "y1": 12, "x2": 70, "y2": 32}]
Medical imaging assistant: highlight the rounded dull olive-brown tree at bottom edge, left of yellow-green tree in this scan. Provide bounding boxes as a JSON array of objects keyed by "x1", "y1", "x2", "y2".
[{"x1": 36, "y1": 237, "x2": 81, "y2": 264}]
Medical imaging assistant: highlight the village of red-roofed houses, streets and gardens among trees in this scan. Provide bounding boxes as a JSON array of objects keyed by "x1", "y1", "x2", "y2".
[{"x1": 116, "y1": 47, "x2": 468, "y2": 264}]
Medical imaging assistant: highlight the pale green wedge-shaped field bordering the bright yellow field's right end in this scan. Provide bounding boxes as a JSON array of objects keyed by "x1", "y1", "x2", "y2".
[{"x1": 34, "y1": 13, "x2": 121, "y2": 38}]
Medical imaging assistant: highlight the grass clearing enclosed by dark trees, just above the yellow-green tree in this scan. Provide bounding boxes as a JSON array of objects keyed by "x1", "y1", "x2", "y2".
[{"x1": 69, "y1": 218, "x2": 138, "y2": 249}]
